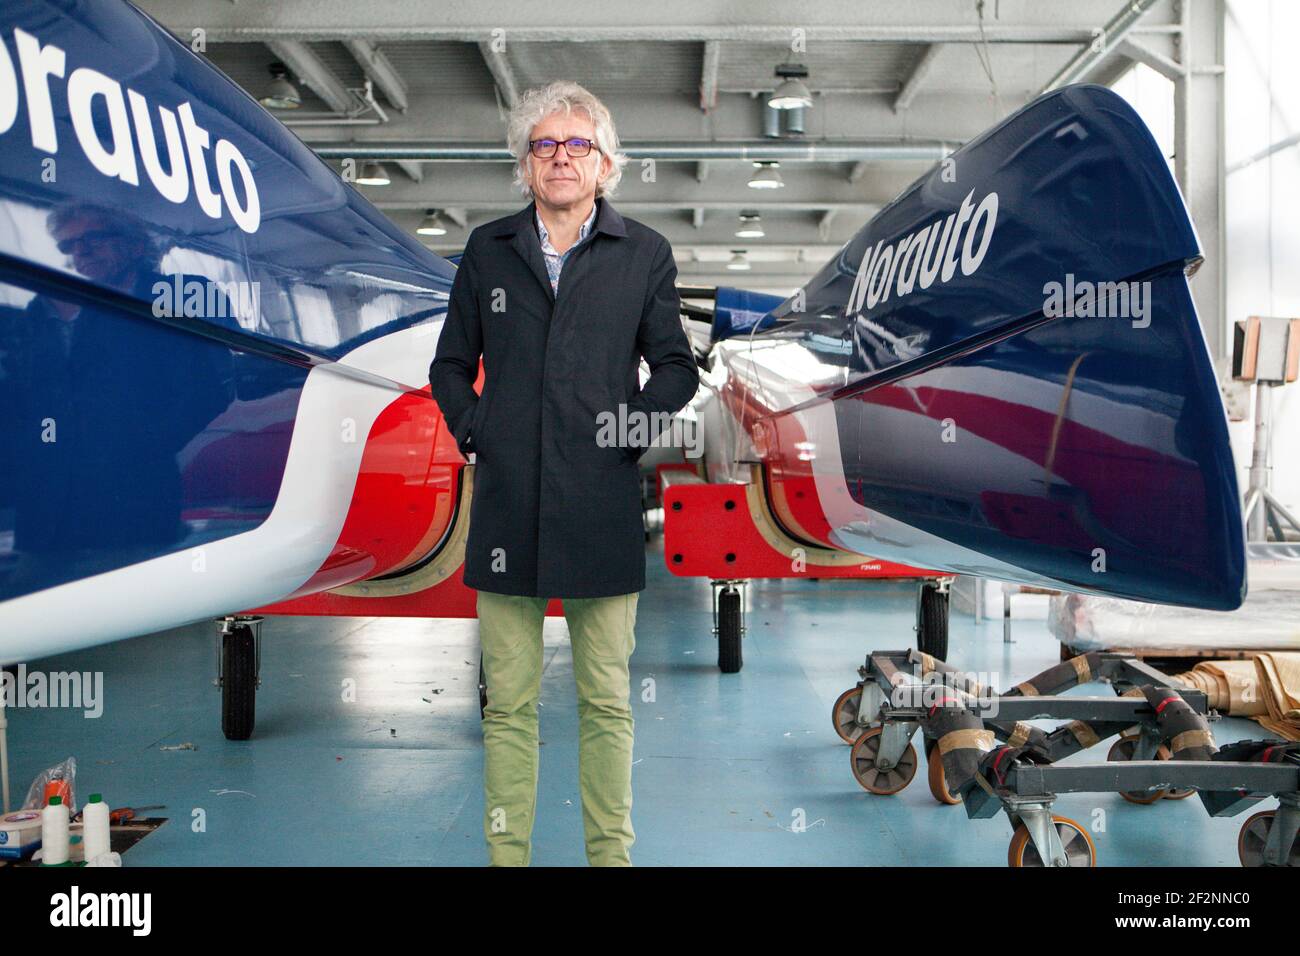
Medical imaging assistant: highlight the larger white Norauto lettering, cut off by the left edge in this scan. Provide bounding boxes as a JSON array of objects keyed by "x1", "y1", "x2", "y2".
[{"x1": 0, "y1": 29, "x2": 261, "y2": 233}]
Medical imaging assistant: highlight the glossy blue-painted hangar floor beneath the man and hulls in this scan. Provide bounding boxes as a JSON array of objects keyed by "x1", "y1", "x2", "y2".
[{"x1": 9, "y1": 546, "x2": 1264, "y2": 866}]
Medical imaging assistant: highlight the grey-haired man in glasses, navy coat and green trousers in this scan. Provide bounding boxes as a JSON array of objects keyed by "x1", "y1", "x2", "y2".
[{"x1": 429, "y1": 82, "x2": 698, "y2": 865}]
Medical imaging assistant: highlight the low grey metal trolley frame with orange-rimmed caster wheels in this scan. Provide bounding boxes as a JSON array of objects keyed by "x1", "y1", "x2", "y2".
[{"x1": 832, "y1": 650, "x2": 1300, "y2": 866}]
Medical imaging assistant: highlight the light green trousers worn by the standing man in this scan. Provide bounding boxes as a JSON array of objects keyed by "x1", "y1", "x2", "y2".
[{"x1": 477, "y1": 591, "x2": 638, "y2": 866}]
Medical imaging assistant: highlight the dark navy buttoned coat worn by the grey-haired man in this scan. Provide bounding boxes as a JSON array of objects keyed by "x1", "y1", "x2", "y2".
[{"x1": 429, "y1": 199, "x2": 699, "y2": 598}]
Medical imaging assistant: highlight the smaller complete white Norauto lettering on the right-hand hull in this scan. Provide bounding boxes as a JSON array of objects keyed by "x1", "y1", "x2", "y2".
[{"x1": 849, "y1": 190, "x2": 997, "y2": 315}]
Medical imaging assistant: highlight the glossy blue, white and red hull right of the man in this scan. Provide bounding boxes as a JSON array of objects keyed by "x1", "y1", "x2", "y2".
[{"x1": 754, "y1": 86, "x2": 1245, "y2": 610}]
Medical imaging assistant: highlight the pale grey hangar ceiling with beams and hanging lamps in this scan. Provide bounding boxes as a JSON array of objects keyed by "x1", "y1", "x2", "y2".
[{"x1": 135, "y1": 0, "x2": 1182, "y2": 293}]
